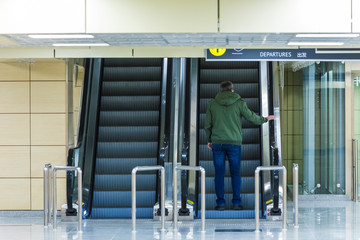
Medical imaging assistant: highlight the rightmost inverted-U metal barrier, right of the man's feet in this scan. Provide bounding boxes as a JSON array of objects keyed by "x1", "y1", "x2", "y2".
[{"x1": 255, "y1": 166, "x2": 287, "y2": 232}]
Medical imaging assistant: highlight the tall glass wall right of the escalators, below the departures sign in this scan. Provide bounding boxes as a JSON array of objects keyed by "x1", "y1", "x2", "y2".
[{"x1": 277, "y1": 62, "x2": 345, "y2": 194}]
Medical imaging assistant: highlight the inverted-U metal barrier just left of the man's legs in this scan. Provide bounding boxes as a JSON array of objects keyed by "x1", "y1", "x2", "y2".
[{"x1": 173, "y1": 166, "x2": 205, "y2": 232}]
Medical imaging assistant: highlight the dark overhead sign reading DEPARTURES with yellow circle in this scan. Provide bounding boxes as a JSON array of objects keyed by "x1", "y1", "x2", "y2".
[{"x1": 206, "y1": 48, "x2": 360, "y2": 61}]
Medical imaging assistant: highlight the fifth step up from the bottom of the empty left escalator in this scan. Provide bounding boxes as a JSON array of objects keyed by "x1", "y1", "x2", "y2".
[{"x1": 97, "y1": 142, "x2": 158, "y2": 158}]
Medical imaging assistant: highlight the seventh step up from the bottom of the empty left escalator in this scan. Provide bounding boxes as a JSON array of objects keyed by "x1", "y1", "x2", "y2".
[{"x1": 99, "y1": 111, "x2": 159, "y2": 126}]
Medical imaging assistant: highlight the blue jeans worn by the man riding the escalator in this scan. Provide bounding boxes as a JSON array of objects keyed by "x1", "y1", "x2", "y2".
[{"x1": 212, "y1": 144, "x2": 241, "y2": 206}]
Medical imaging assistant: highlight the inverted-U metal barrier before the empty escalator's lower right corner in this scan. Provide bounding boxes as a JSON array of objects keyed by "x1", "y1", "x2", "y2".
[{"x1": 131, "y1": 166, "x2": 165, "y2": 232}]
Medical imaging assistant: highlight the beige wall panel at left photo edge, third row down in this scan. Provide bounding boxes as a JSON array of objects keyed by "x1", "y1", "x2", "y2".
[{"x1": 0, "y1": 114, "x2": 30, "y2": 145}]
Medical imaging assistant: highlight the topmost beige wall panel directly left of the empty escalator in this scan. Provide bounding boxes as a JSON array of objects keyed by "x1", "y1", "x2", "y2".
[{"x1": 31, "y1": 60, "x2": 66, "y2": 81}]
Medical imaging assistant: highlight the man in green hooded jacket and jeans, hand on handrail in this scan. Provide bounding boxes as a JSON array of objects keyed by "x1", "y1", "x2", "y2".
[{"x1": 205, "y1": 81, "x2": 274, "y2": 210}]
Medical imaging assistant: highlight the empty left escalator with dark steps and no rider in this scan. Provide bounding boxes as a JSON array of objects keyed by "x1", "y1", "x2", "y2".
[{"x1": 79, "y1": 59, "x2": 167, "y2": 218}]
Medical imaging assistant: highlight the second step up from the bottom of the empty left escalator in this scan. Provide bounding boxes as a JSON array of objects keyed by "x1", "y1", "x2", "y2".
[{"x1": 93, "y1": 191, "x2": 155, "y2": 208}]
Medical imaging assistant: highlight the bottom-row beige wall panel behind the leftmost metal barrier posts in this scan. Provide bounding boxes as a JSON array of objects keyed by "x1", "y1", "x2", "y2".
[{"x1": 31, "y1": 178, "x2": 66, "y2": 210}]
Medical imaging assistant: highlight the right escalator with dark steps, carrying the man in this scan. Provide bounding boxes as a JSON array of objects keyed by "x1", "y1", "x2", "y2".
[{"x1": 197, "y1": 59, "x2": 262, "y2": 218}]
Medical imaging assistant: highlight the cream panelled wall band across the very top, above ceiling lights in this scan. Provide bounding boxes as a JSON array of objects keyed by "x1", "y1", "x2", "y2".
[{"x1": 0, "y1": 0, "x2": 354, "y2": 34}]
